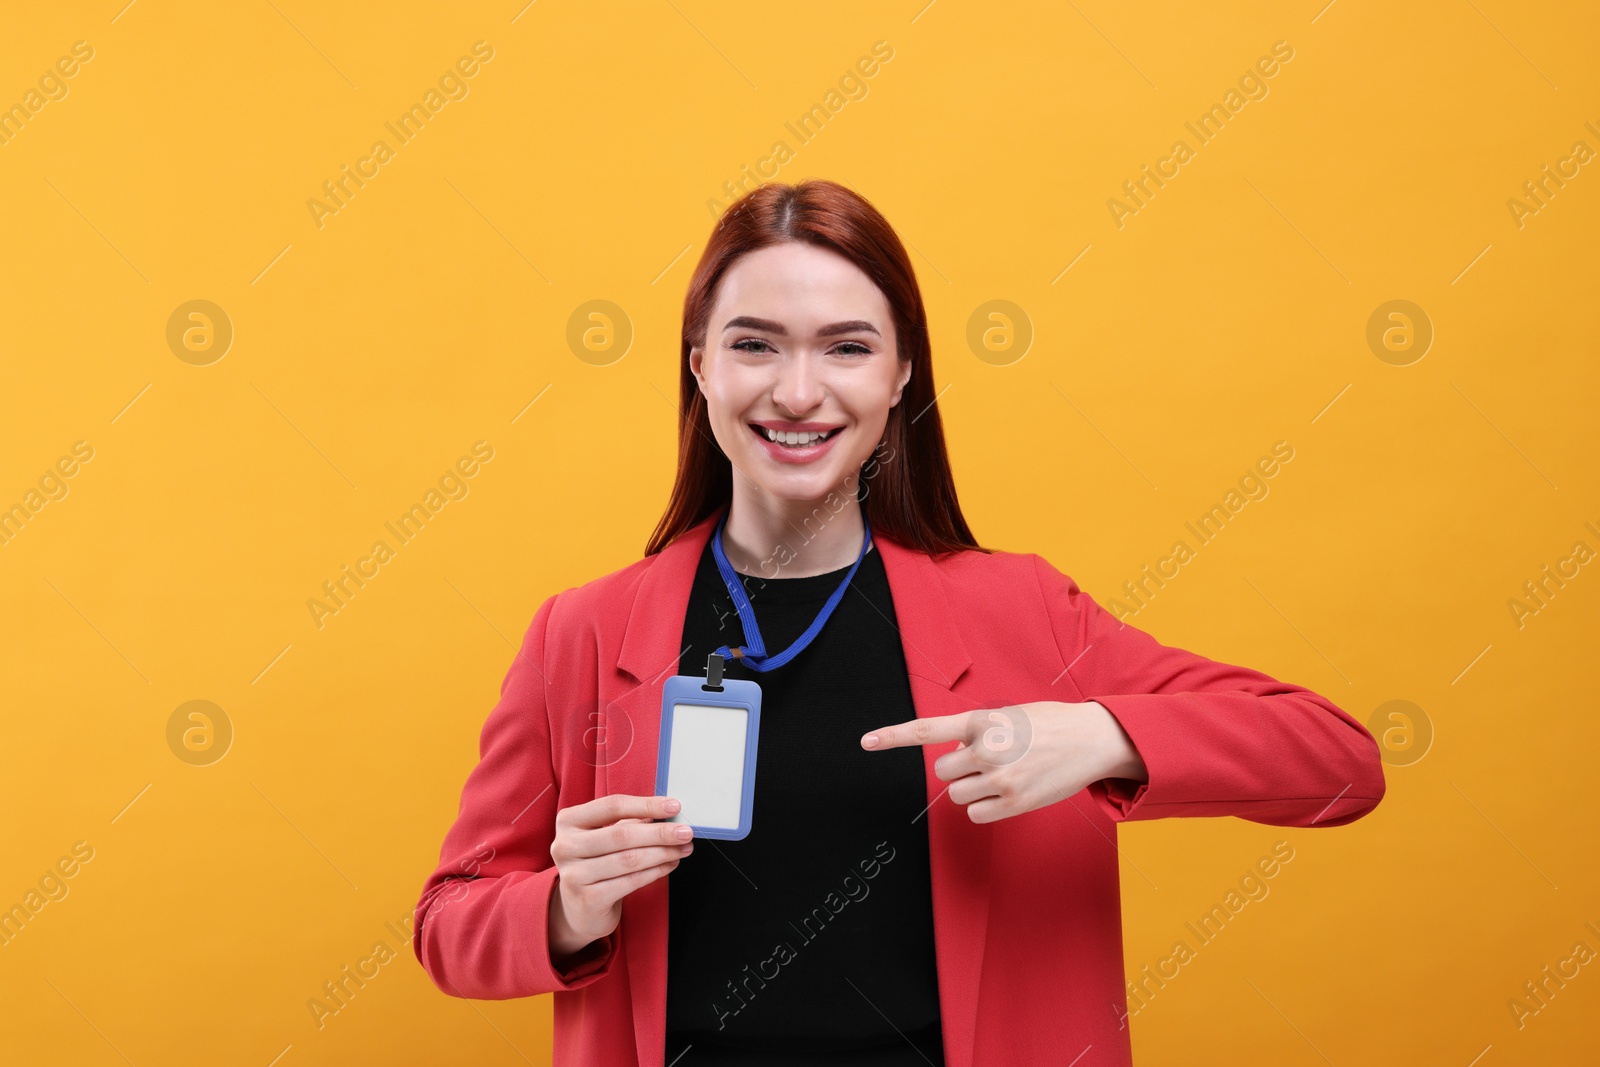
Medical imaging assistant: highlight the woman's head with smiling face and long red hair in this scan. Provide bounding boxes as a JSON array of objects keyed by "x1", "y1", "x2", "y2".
[{"x1": 645, "y1": 181, "x2": 978, "y2": 566}]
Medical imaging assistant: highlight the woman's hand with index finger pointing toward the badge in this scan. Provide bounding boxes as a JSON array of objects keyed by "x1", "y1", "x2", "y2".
[{"x1": 861, "y1": 701, "x2": 1149, "y2": 822}]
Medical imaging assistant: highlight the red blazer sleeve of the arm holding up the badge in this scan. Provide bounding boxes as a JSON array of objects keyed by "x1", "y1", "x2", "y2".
[{"x1": 411, "y1": 593, "x2": 619, "y2": 1000}]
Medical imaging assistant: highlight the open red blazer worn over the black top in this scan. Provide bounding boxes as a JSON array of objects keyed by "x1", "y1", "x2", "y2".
[{"x1": 413, "y1": 512, "x2": 1384, "y2": 1067}]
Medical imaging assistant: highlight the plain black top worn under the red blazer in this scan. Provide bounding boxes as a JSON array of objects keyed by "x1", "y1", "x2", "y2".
[{"x1": 666, "y1": 541, "x2": 944, "y2": 1067}]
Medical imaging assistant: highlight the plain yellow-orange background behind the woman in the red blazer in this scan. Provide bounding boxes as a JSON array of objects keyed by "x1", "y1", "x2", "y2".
[{"x1": 0, "y1": 0, "x2": 1600, "y2": 1067}]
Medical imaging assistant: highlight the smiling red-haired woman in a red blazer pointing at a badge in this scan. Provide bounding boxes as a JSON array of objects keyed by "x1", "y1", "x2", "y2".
[{"x1": 413, "y1": 181, "x2": 1384, "y2": 1067}]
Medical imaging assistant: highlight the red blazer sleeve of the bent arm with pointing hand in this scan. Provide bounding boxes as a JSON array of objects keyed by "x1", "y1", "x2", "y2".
[{"x1": 1034, "y1": 555, "x2": 1384, "y2": 827}]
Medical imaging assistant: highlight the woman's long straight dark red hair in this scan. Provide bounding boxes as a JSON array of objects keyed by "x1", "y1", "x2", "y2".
[{"x1": 645, "y1": 179, "x2": 989, "y2": 555}]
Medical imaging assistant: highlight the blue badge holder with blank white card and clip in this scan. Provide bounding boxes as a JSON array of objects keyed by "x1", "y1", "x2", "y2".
[{"x1": 656, "y1": 653, "x2": 762, "y2": 841}]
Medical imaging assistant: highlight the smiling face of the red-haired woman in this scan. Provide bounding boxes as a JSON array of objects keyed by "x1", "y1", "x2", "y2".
[{"x1": 690, "y1": 242, "x2": 910, "y2": 501}]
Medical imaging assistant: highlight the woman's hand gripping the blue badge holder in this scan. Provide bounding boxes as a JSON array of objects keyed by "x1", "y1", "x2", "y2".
[{"x1": 549, "y1": 793, "x2": 694, "y2": 961}]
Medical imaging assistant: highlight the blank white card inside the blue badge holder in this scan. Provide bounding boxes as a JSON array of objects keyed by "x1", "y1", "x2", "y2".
[{"x1": 666, "y1": 704, "x2": 750, "y2": 830}]
